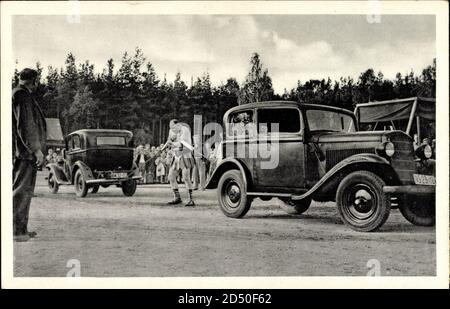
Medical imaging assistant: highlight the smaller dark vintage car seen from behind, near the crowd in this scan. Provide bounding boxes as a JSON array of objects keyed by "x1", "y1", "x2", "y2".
[{"x1": 47, "y1": 129, "x2": 141, "y2": 197}]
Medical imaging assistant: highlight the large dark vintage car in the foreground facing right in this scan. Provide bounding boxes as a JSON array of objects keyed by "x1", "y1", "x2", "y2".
[{"x1": 207, "y1": 101, "x2": 435, "y2": 231}]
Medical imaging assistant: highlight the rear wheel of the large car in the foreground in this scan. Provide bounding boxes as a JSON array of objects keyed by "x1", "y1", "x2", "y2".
[{"x1": 217, "y1": 170, "x2": 252, "y2": 218}]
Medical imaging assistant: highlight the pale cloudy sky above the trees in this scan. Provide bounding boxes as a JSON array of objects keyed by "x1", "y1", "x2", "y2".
[{"x1": 12, "y1": 15, "x2": 436, "y2": 93}]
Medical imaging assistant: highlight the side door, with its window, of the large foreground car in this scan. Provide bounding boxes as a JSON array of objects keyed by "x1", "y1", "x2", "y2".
[{"x1": 254, "y1": 107, "x2": 305, "y2": 191}]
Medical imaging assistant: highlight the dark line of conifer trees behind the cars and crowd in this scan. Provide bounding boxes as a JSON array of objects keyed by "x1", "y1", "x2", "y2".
[{"x1": 12, "y1": 48, "x2": 436, "y2": 144}]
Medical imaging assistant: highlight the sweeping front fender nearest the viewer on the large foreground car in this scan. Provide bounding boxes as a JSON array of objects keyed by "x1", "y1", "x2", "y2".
[{"x1": 292, "y1": 153, "x2": 399, "y2": 200}]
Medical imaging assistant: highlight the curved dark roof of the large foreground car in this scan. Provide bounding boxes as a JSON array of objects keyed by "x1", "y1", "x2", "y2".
[{"x1": 224, "y1": 100, "x2": 355, "y2": 119}]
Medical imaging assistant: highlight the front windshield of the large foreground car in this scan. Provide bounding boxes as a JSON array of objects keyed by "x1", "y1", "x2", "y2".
[{"x1": 306, "y1": 109, "x2": 355, "y2": 132}]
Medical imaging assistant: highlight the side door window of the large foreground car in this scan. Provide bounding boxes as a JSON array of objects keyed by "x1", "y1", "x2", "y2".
[{"x1": 257, "y1": 108, "x2": 303, "y2": 134}]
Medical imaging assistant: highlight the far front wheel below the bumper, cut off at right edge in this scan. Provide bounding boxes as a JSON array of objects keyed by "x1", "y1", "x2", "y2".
[{"x1": 398, "y1": 196, "x2": 436, "y2": 226}]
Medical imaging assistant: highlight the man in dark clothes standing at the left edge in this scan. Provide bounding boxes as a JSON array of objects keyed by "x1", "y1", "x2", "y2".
[{"x1": 12, "y1": 69, "x2": 46, "y2": 241}]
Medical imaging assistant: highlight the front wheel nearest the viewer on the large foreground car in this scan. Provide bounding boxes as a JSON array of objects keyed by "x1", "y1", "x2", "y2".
[{"x1": 336, "y1": 171, "x2": 391, "y2": 232}]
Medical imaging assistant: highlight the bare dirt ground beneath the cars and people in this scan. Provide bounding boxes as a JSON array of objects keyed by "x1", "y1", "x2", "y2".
[{"x1": 14, "y1": 174, "x2": 436, "y2": 277}]
